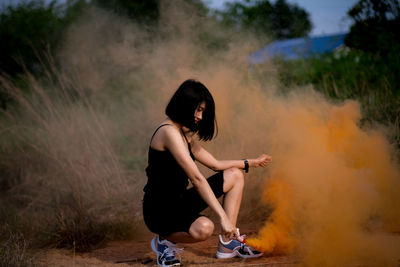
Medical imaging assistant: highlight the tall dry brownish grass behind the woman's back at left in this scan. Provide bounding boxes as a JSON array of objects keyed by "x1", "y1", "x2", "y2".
[{"x1": 0, "y1": 58, "x2": 144, "y2": 251}]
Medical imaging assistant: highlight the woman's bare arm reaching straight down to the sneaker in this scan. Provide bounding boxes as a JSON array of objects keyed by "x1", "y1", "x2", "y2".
[{"x1": 160, "y1": 127, "x2": 236, "y2": 236}]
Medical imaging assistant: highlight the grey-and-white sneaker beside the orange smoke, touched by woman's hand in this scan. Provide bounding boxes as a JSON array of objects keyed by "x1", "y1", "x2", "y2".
[{"x1": 217, "y1": 232, "x2": 263, "y2": 259}]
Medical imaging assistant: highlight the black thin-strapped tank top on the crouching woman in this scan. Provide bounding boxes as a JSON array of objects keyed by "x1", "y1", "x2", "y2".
[{"x1": 143, "y1": 124, "x2": 194, "y2": 197}]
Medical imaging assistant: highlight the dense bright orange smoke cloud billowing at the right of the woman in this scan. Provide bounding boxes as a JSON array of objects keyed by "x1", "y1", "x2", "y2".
[{"x1": 248, "y1": 98, "x2": 400, "y2": 266}]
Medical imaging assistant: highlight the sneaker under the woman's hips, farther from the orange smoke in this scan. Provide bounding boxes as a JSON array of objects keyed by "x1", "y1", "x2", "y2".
[{"x1": 151, "y1": 236, "x2": 183, "y2": 266}]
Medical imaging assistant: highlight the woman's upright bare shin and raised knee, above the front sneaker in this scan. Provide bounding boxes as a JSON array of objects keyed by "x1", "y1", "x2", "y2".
[{"x1": 223, "y1": 168, "x2": 244, "y2": 228}]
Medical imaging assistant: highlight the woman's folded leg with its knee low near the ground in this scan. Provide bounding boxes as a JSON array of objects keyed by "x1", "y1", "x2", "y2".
[{"x1": 161, "y1": 216, "x2": 214, "y2": 243}]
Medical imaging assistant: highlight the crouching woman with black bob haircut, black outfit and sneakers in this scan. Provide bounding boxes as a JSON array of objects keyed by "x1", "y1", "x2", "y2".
[{"x1": 143, "y1": 80, "x2": 271, "y2": 266}]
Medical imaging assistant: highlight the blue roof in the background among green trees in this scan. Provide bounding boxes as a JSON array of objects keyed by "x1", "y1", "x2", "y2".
[{"x1": 249, "y1": 33, "x2": 347, "y2": 64}]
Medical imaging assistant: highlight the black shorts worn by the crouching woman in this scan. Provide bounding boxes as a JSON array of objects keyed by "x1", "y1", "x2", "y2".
[{"x1": 143, "y1": 171, "x2": 224, "y2": 236}]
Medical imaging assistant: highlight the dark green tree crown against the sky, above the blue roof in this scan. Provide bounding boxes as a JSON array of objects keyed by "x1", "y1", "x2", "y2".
[{"x1": 219, "y1": 0, "x2": 312, "y2": 39}]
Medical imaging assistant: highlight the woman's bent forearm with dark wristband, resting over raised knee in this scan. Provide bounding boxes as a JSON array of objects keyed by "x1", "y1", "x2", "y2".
[{"x1": 191, "y1": 141, "x2": 272, "y2": 171}]
